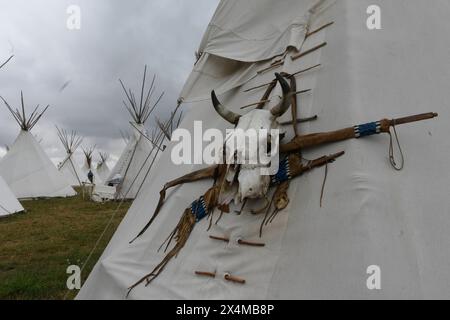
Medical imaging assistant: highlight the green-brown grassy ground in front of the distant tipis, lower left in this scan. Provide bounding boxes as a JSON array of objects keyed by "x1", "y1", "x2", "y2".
[{"x1": 0, "y1": 192, "x2": 130, "y2": 299}]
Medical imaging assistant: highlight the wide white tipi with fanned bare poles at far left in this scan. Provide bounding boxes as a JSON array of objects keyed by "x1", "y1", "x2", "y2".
[{"x1": 0, "y1": 94, "x2": 76, "y2": 199}]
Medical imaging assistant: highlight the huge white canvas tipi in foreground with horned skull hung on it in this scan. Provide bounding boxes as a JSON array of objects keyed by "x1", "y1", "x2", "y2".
[{"x1": 78, "y1": 0, "x2": 450, "y2": 300}]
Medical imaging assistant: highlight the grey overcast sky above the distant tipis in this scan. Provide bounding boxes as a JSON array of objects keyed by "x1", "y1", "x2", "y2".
[{"x1": 0, "y1": 0, "x2": 219, "y2": 166}]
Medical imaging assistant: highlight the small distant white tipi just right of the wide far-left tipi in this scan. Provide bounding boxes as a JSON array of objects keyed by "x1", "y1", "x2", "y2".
[{"x1": 56, "y1": 127, "x2": 84, "y2": 186}]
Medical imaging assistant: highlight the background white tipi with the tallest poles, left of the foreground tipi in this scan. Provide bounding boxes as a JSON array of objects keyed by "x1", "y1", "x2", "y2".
[{"x1": 105, "y1": 66, "x2": 164, "y2": 199}]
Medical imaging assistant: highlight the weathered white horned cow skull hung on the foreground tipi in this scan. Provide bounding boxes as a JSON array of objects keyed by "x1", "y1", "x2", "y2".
[{"x1": 211, "y1": 73, "x2": 294, "y2": 202}]
